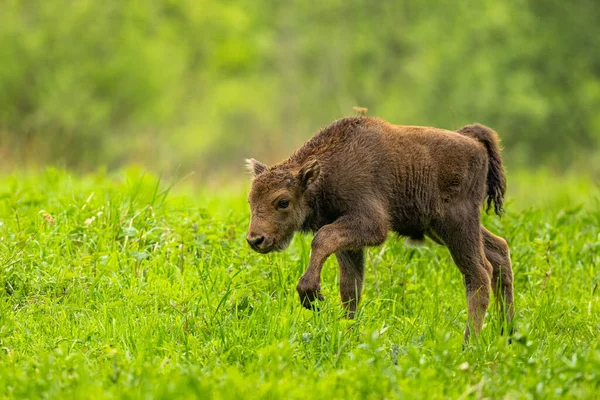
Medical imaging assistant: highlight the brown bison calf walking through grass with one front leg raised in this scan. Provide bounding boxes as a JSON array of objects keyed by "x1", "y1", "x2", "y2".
[{"x1": 247, "y1": 117, "x2": 514, "y2": 340}]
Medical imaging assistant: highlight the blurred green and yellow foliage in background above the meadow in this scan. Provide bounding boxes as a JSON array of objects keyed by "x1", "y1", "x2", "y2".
[{"x1": 0, "y1": 0, "x2": 600, "y2": 172}]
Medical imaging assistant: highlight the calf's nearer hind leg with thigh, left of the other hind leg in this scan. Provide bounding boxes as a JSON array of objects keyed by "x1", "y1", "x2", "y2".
[{"x1": 432, "y1": 217, "x2": 492, "y2": 342}]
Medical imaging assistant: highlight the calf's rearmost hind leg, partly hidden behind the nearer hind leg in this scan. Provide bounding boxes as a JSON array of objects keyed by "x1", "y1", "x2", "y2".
[{"x1": 481, "y1": 226, "x2": 515, "y2": 330}]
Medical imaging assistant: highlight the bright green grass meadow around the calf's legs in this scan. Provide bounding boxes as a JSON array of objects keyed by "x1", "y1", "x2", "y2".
[{"x1": 0, "y1": 169, "x2": 600, "y2": 399}]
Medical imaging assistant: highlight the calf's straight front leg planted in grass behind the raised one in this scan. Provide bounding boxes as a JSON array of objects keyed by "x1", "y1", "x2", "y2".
[{"x1": 335, "y1": 249, "x2": 365, "y2": 319}]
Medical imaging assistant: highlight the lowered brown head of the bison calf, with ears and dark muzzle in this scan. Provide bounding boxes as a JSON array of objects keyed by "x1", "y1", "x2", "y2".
[{"x1": 246, "y1": 159, "x2": 320, "y2": 253}]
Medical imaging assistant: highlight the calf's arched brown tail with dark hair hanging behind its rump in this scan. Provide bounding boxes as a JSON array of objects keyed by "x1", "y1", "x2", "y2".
[{"x1": 457, "y1": 124, "x2": 506, "y2": 216}]
